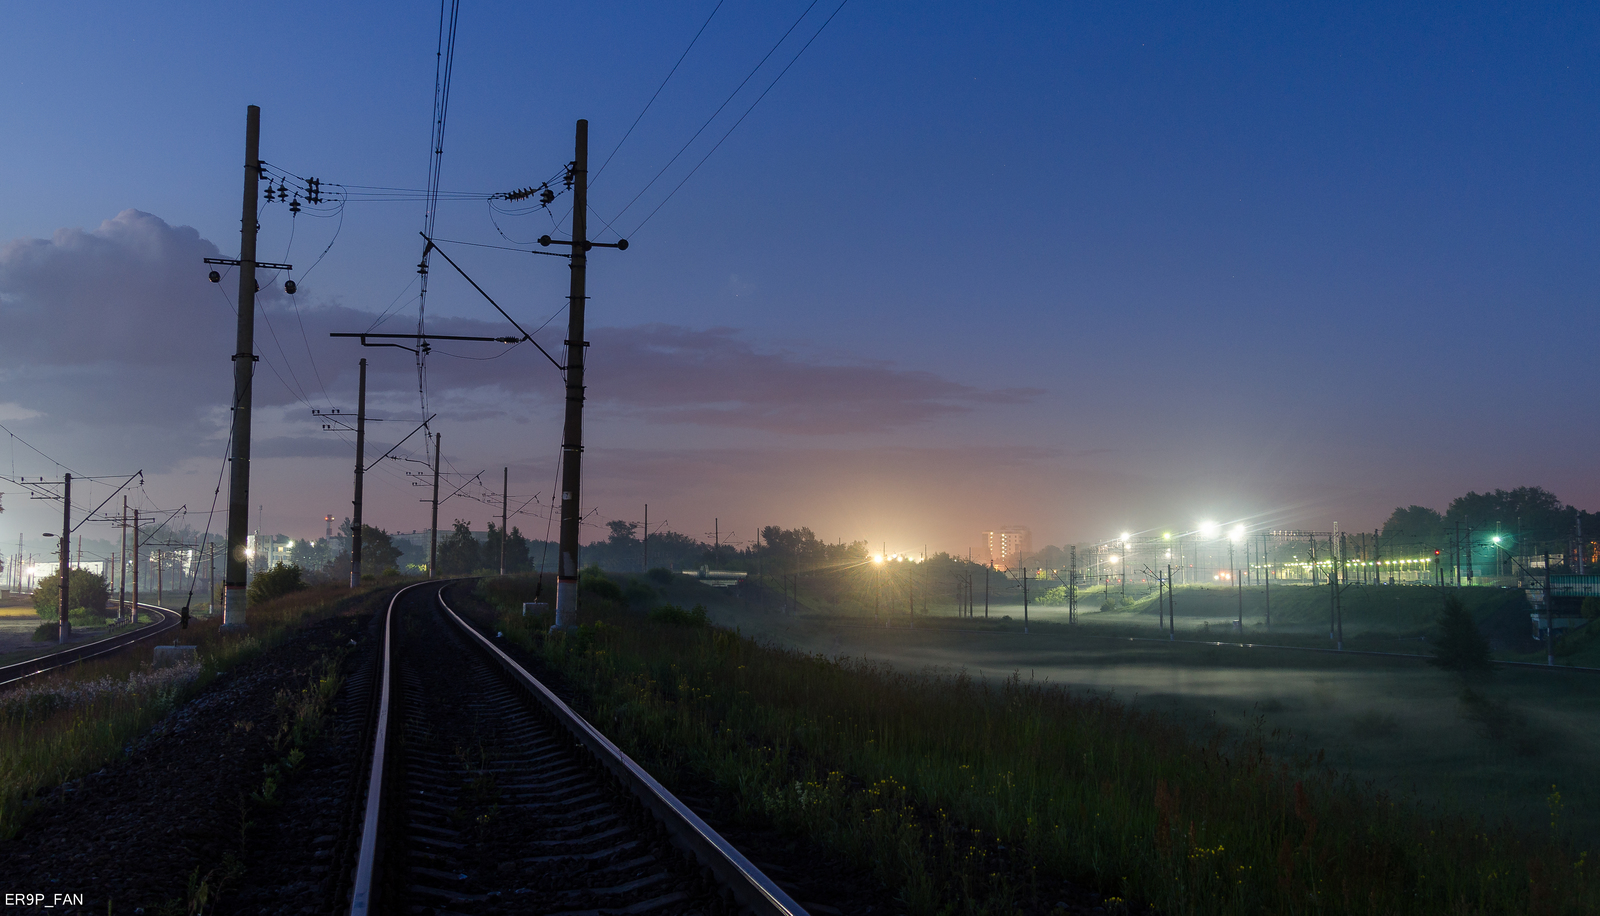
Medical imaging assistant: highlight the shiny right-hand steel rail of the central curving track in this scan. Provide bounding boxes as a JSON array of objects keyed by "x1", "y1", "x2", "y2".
[{"x1": 435, "y1": 589, "x2": 808, "y2": 916}]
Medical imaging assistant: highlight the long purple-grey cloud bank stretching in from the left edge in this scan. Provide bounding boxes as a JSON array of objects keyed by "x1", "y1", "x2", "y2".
[{"x1": 0, "y1": 210, "x2": 1040, "y2": 480}]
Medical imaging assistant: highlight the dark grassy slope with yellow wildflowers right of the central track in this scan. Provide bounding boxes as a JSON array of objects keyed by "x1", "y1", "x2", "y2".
[{"x1": 480, "y1": 581, "x2": 1600, "y2": 914}]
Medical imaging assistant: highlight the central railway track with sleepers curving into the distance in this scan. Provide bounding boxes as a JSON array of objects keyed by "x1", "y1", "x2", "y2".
[{"x1": 344, "y1": 581, "x2": 805, "y2": 916}]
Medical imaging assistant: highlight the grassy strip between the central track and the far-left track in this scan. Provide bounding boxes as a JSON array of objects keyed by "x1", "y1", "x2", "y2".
[{"x1": 0, "y1": 588, "x2": 390, "y2": 838}]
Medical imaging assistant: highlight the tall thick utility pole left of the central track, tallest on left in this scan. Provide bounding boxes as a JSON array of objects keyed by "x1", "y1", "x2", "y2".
[{"x1": 225, "y1": 106, "x2": 261, "y2": 628}]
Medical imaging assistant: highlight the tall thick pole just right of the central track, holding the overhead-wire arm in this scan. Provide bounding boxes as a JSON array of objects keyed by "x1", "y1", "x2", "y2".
[{"x1": 555, "y1": 120, "x2": 589, "y2": 629}]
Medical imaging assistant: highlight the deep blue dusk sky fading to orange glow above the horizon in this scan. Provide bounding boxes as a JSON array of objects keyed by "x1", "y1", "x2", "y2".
[{"x1": 0, "y1": 0, "x2": 1600, "y2": 566}]
